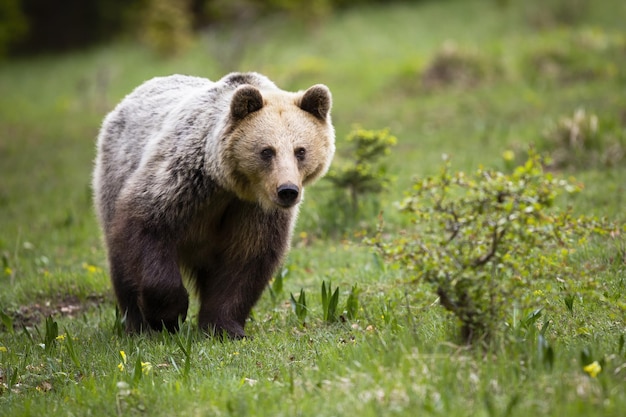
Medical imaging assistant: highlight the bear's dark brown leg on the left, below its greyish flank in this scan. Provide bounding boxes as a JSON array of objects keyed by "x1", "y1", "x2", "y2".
[{"x1": 109, "y1": 216, "x2": 189, "y2": 333}]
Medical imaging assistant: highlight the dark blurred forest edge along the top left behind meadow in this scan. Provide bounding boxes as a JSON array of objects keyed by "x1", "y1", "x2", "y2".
[{"x1": 0, "y1": 0, "x2": 421, "y2": 57}]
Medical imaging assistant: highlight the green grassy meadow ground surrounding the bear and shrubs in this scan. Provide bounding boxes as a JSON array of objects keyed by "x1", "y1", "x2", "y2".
[{"x1": 0, "y1": 0, "x2": 626, "y2": 416}]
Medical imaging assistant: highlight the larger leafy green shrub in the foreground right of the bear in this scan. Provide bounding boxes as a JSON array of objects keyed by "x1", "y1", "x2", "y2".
[{"x1": 369, "y1": 152, "x2": 605, "y2": 343}]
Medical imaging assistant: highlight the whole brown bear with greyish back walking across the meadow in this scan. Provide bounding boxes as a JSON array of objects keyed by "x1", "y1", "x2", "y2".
[{"x1": 92, "y1": 72, "x2": 335, "y2": 338}]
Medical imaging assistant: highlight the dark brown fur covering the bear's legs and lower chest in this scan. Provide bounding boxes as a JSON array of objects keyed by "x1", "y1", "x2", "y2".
[{"x1": 107, "y1": 190, "x2": 291, "y2": 337}]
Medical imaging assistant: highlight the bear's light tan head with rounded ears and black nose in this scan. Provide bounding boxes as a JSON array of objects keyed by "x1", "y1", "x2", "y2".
[{"x1": 223, "y1": 85, "x2": 335, "y2": 211}]
